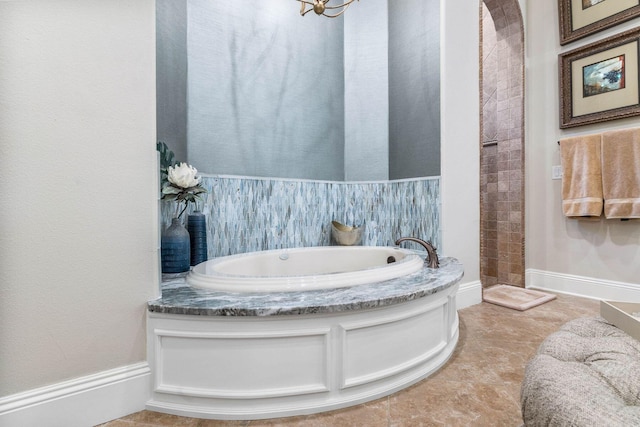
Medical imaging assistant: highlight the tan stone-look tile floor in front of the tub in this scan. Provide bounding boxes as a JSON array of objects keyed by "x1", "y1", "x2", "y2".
[{"x1": 101, "y1": 295, "x2": 599, "y2": 427}]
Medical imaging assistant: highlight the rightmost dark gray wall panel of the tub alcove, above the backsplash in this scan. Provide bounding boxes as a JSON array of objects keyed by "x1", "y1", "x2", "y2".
[{"x1": 389, "y1": 0, "x2": 440, "y2": 179}]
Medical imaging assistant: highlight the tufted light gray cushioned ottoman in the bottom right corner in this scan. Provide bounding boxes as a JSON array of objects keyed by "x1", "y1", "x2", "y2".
[{"x1": 521, "y1": 318, "x2": 640, "y2": 427}]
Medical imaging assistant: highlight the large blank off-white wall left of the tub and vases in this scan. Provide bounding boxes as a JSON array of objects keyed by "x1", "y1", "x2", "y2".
[{"x1": 0, "y1": 0, "x2": 158, "y2": 400}]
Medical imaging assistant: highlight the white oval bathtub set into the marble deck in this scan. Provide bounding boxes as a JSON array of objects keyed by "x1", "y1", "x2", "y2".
[{"x1": 187, "y1": 246, "x2": 424, "y2": 293}]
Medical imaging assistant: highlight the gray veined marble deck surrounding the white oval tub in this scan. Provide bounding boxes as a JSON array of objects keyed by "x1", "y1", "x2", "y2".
[{"x1": 147, "y1": 257, "x2": 464, "y2": 316}]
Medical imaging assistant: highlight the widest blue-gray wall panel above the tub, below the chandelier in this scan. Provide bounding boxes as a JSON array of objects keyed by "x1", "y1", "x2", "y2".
[{"x1": 187, "y1": 0, "x2": 344, "y2": 180}]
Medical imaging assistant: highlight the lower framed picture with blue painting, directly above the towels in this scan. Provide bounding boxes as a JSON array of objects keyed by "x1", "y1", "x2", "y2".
[{"x1": 558, "y1": 27, "x2": 640, "y2": 128}]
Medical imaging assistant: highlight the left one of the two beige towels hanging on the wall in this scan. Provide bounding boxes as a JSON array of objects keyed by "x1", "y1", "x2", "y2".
[{"x1": 560, "y1": 134, "x2": 603, "y2": 219}]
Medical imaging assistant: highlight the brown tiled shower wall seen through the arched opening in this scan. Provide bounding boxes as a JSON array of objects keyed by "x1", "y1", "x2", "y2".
[{"x1": 480, "y1": 0, "x2": 524, "y2": 287}]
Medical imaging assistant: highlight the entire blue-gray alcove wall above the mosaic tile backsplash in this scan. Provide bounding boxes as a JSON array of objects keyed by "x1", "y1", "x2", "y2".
[{"x1": 157, "y1": 0, "x2": 440, "y2": 181}]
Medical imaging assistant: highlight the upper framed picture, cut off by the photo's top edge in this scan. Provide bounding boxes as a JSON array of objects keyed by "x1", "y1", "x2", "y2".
[{"x1": 558, "y1": 0, "x2": 640, "y2": 45}]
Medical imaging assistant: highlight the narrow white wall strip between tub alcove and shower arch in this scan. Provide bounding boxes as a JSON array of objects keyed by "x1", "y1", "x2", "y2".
[{"x1": 439, "y1": 0, "x2": 480, "y2": 288}]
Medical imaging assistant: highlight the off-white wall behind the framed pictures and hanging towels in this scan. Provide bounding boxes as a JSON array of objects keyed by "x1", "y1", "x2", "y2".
[{"x1": 525, "y1": 0, "x2": 640, "y2": 288}]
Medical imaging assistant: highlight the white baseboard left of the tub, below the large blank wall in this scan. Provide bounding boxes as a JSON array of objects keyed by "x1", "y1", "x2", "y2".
[{"x1": 0, "y1": 362, "x2": 151, "y2": 427}]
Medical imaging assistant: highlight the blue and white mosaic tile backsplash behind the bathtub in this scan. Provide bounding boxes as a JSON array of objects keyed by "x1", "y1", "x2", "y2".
[{"x1": 162, "y1": 175, "x2": 441, "y2": 259}]
